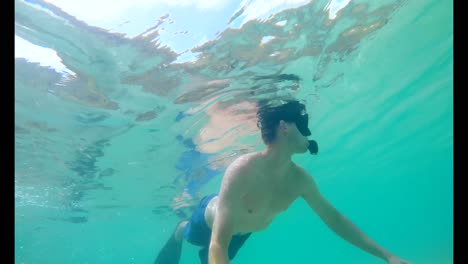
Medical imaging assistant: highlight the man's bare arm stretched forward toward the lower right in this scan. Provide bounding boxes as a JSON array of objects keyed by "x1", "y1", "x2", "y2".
[{"x1": 301, "y1": 169, "x2": 410, "y2": 264}]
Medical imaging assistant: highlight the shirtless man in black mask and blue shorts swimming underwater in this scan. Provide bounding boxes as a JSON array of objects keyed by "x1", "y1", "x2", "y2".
[{"x1": 155, "y1": 100, "x2": 409, "y2": 264}]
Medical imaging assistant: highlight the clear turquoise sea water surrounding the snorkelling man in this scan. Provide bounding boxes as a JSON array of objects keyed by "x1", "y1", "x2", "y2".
[{"x1": 15, "y1": 1, "x2": 453, "y2": 264}]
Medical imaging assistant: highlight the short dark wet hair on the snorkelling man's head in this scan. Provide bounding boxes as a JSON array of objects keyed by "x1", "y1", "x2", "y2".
[{"x1": 257, "y1": 100, "x2": 305, "y2": 145}]
